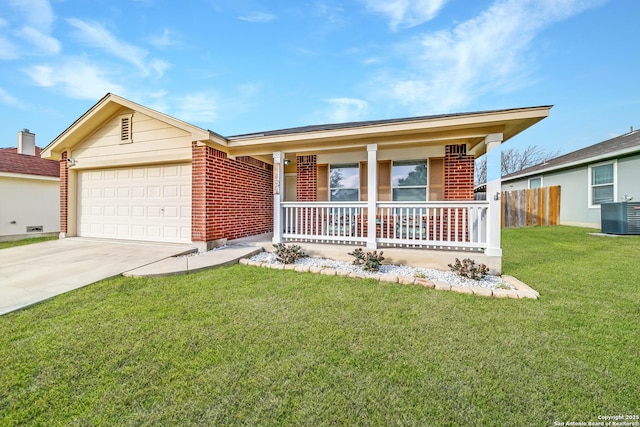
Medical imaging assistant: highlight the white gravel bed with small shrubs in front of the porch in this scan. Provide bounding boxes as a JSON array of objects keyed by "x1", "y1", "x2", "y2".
[{"x1": 250, "y1": 252, "x2": 514, "y2": 289}]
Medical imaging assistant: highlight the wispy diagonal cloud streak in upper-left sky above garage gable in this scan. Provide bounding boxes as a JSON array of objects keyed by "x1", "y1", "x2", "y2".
[{"x1": 67, "y1": 18, "x2": 167, "y2": 77}]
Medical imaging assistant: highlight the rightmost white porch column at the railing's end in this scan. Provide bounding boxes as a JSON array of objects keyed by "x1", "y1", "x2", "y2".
[{"x1": 484, "y1": 133, "x2": 503, "y2": 257}]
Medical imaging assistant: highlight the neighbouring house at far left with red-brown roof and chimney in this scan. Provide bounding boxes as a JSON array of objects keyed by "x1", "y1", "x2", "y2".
[{"x1": 0, "y1": 129, "x2": 60, "y2": 241}]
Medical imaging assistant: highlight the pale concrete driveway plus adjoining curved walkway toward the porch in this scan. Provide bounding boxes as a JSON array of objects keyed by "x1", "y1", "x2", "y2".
[{"x1": 0, "y1": 237, "x2": 262, "y2": 315}]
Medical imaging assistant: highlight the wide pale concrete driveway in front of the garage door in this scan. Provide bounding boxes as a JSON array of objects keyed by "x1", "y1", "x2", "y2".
[{"x1": 0, "y1": 237, "x2": 195, "y2": 315}]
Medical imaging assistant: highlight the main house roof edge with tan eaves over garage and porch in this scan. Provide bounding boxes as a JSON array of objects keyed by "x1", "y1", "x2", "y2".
[{"x1": 42, "y1": 93, "x2": 551, "y2": 162}]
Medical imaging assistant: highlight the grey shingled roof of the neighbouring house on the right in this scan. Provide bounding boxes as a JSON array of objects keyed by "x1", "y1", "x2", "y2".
[{"x1": 502, "y1": 130, "x2": 640, "y2": 181}]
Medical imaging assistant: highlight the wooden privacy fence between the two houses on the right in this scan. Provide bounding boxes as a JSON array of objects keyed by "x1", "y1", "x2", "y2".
[{"x1": 500, "y1": 185, "x2": 560, "y2": 228}]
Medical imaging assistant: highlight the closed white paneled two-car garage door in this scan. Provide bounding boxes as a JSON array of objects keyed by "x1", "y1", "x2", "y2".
[{"x1": 78, "y1": 164, "x2": 191, "y2": 243}]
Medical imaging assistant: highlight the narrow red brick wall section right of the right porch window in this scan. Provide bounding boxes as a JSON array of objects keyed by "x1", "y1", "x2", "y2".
[{"x1": 444, "y1": 145, "x2": 475, "y2": 200}]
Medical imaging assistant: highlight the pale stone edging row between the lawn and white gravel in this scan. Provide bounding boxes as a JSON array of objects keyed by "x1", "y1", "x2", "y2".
[{"x1": 238, "y1": 258, "x2": 540, "y2": 299}]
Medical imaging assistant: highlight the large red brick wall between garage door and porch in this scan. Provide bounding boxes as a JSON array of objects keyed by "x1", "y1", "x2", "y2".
[{"x1": 191, "y1": 142, "x2": 273, "y2": 242}]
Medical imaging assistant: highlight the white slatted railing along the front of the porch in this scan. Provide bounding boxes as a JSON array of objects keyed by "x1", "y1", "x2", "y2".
[{"x1": 281, "y1": 201, "x2": 489, "y2": 250}]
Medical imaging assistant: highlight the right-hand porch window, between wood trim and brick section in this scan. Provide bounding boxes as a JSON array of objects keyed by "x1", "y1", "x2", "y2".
[{"x1": 391, "y1": 160, "x2": 427, "y2": 202}]
